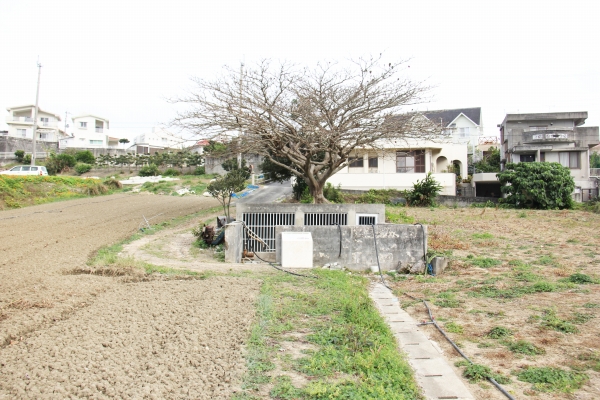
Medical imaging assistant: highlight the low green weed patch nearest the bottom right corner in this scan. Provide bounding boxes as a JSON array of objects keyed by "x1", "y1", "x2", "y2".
[{"x1": 517, "y1": 367, "x2": 589, "y2": 393}]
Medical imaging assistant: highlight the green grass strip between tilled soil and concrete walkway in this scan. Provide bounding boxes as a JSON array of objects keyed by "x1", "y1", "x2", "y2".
[{"x1": 235, "y1": 270, "x2": 420, "y2": 400}]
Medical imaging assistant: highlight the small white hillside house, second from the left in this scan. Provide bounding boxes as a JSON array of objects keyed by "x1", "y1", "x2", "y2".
[{"x1": 60, "y1": 114, "x2": 119, "y2": 149}]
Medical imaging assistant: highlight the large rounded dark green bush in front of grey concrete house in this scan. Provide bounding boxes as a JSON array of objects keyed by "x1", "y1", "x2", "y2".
[{"x1": 497, "y1": 162, "x2": 575, "y2": 210}]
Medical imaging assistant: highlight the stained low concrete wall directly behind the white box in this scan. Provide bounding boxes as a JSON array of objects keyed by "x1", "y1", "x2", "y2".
[{"x1": 275, "y1": 224, "x2": 427, "y2": 271}]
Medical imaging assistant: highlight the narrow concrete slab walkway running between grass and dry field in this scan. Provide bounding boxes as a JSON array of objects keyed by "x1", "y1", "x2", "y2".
[{"x1": 369, "y1": 283, "x2": 475, "y2": 400}]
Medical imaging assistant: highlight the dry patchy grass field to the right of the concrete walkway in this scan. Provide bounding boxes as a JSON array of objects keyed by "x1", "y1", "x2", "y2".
[{"x1": 391, "y1": 208, "x2": 600, "y2": 399}]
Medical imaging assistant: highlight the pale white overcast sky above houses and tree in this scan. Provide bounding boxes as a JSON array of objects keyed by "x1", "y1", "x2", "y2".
[{"x1": 0, "y1": 0, "x2": 600, "y2": 137}]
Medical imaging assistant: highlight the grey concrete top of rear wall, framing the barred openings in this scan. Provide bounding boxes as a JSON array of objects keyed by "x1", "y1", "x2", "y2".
[{"x1": 235, "y1": 203, "x2": 385, "y2": 226}]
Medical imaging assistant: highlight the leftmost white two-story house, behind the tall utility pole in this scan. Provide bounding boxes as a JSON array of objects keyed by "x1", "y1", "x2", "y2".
[{"x1": 6, "y1": 105, "x2": 64, "y2": 142}]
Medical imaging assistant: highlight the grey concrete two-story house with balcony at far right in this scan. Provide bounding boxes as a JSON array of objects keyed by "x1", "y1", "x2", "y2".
[{"x1": 490, "y1": 111, "x2": 600, "y2": 198}]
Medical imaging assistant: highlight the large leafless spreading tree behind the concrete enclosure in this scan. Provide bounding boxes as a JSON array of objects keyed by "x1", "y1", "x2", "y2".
[{"x1": 173, "y1": 56, "x2": 439, "y2": 203}]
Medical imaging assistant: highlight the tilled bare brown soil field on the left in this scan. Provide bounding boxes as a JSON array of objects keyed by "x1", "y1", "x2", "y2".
[{"x1": 0, "y1": 194, "x2": 259, "y2": 398}]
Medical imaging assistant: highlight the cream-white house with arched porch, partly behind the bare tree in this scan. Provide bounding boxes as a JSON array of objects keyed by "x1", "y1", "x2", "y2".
[{"x1": 328, "y1": 109, "x2": 474, "y2": 196}]
